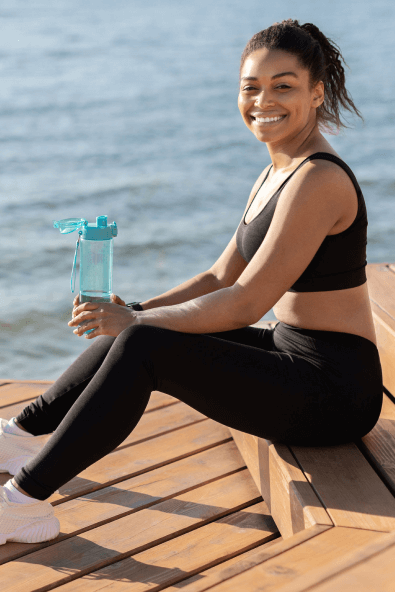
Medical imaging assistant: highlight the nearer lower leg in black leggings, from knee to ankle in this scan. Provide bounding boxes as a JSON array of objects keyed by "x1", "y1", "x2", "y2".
[{"x1": 14, "y1": 327, "x2": 155, "y2": 500}]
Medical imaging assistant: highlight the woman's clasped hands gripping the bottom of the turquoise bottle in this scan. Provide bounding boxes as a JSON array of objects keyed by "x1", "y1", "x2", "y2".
[{"x1": 68, "y1": 294, "x2": 137, "y2": 339}]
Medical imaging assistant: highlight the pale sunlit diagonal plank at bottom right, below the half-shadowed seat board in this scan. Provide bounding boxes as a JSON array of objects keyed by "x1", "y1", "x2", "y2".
[{"x1": 198, "y1": 527, "x2": 382, "y2": 592}]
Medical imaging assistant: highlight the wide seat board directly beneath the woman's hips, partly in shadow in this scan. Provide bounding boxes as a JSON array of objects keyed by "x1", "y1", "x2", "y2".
[{"x1": 291, "y1": 443, "x2": 395, "y2": 532}]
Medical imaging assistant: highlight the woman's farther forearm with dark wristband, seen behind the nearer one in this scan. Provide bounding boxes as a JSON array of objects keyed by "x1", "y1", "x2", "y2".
[{"x1": 141, "y1": 271, "x2": 222, "y2": 310}]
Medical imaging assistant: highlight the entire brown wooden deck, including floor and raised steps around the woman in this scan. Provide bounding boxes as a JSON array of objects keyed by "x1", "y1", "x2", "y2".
[{"x1": 0, "y1": 264, "x2": 395, "y2": 592}]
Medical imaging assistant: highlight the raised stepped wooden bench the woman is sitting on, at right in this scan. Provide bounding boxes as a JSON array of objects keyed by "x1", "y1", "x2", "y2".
[{"x1": 176, "y1": 264, "x2": 395, "y2": 592}]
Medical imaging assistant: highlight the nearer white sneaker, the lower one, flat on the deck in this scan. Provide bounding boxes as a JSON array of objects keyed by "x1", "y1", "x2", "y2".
[{"x1": 0, "y1": 487, "x2": 60, "y2": 545}]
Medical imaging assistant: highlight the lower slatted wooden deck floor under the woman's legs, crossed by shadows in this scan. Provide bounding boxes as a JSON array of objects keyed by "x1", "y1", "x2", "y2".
[{"x1": 0, "y1": 380, "x2": 280, "y2": 592}]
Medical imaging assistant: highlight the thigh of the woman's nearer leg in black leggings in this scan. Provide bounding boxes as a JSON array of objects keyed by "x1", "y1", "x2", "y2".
[{"x1": 126, "y1": 325, "x2": 326, "y2": 441}]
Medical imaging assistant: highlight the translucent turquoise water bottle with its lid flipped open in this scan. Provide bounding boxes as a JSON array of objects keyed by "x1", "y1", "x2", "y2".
[{"x1": 54, "y1": 216, "x2": 118, "y2": 333}]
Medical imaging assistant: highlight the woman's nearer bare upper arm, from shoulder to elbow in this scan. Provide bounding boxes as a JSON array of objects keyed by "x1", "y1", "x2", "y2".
[{"x1": 234, "y1": 161, "x2": 350, "y2": 322}]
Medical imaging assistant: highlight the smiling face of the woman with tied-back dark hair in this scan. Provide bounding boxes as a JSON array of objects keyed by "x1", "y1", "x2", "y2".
[{"x1": 238, "y1": 48, "x2": 324, "y2": 143}]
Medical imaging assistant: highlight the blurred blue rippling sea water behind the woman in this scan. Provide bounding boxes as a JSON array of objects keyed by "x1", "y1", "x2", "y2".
[{"x1": 0, "y1": 0, "x2": 395, "y2": 379}]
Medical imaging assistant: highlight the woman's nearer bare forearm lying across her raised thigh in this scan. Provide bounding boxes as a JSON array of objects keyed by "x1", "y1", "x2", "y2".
[{"x1": 135, "y1": 286, "x2": 255, "y2": 333}]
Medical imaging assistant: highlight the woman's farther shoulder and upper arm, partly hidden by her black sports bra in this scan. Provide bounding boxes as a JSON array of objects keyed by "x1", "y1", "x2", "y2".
[{"x1": 209, "y1": 165, "x2": 270, "y2": 288}]
